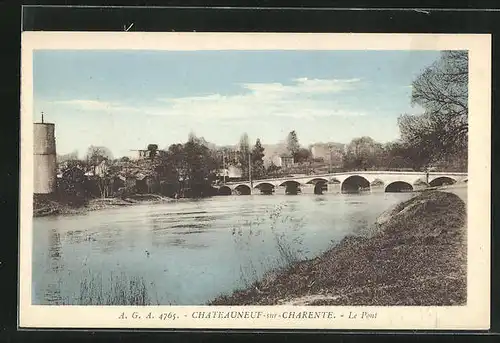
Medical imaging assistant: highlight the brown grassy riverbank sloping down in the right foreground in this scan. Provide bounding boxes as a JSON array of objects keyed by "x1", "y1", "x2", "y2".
[{"x1": 210, "y1": 190, "x2": 467, "y2": 306}]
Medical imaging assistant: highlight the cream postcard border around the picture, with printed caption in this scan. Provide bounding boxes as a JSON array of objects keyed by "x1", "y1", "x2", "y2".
[{"x1": 18, "y1": 32, "x2": 491, "y2": 330}]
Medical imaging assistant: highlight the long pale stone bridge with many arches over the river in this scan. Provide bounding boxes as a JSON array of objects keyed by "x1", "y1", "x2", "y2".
[{"x1": 219, "y1": 171, "x2": 467, "y2": 195}]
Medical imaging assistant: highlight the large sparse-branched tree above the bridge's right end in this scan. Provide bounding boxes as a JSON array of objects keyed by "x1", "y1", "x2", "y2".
[{"x1": 398, "y1": 51, "x2": 469, "y2": 171}]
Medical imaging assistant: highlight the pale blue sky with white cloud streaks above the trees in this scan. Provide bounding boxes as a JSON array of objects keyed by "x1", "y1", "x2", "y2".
[{"x1": 33, "y1": 50, "x2": 439, "y2": 157}]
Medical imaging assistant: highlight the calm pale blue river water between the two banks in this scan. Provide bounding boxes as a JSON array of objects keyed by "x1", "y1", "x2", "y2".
[{"x1": 32, "y1": 192, "x2": 411, "y2": 305}]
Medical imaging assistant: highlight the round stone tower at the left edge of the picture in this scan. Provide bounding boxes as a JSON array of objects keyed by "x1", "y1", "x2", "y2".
[{"x1": 33, "y1": 122, "x2": 57, "y2": 194}]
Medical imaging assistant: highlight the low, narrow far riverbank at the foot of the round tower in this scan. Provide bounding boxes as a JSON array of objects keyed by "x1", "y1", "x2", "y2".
[{"x1": 33, "y1": 194, "x2": 174, "y2": 217}]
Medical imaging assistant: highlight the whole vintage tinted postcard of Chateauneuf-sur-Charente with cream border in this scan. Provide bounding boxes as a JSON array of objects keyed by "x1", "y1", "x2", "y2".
[{"x1": 19, "y1": 32, "x2": 491, "y2": 330}]
